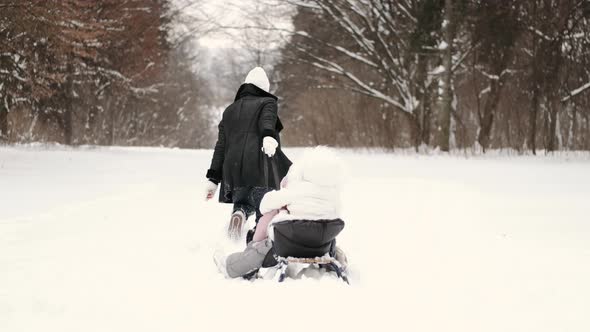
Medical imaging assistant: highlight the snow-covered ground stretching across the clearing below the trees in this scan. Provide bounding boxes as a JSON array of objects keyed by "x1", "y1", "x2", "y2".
[{"x1": 0, "y1": 147, "x2": 590, "y2": 332}]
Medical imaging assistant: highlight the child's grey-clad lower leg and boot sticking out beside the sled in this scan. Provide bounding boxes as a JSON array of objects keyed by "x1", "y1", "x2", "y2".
[{"x1": 226, "y1": 239, "x2": 272, "y2": 278}]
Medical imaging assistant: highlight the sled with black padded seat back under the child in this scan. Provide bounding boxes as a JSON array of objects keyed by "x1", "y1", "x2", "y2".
[{"x1": 273, "y1": 219, "x2": 350, "y2": 284}]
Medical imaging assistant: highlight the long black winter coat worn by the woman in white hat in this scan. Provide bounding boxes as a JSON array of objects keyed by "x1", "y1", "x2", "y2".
[{"x1": 207, "y1": 84, "x2": 291, "y2": 203}]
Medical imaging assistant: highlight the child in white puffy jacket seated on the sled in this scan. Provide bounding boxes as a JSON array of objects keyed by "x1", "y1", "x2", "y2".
[{"x1": 215, "y1": 147, "x2": 345, "y2": 278}]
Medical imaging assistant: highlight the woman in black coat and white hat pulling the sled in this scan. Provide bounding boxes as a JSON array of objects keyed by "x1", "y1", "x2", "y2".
[{"x1": 206, "y1": 67, "x2": 291, "y2": 241}]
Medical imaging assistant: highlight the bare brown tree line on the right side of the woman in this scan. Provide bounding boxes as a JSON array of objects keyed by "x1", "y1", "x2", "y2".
[{"x1": 276, "y1": 0, "x2": 590, "y2": 152}]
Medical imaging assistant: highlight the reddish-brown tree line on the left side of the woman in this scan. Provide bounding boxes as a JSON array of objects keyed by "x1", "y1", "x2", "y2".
[{"x1": 0, "y1": 0, "x2": 209, "y2": 147}]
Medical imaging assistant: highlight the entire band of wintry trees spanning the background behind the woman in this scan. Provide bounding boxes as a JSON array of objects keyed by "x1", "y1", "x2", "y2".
[{"x1": 0, "y1": 0, "x2": 590, "y2": 153}]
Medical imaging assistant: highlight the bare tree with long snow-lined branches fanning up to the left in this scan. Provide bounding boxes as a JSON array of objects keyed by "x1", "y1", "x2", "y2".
[{"x1": 274, "y1": 0, "x2": 470, "y2": 149}]
